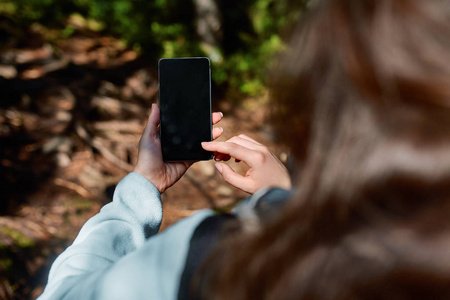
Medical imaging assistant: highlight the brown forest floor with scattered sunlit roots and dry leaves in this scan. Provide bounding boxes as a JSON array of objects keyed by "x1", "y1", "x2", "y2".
[{"x1": 0, "y1": 28, "x2": 286, "y2": 299}]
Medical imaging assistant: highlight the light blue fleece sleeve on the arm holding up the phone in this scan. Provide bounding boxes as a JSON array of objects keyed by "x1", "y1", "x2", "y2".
[{"x1": 39, "y1": 173, "x2": 162, "y2": 300}]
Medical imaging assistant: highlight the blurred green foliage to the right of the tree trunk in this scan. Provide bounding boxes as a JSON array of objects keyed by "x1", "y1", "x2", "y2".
[{"x1": 216, "y1": 0, "x2": 307, "y2": 96}]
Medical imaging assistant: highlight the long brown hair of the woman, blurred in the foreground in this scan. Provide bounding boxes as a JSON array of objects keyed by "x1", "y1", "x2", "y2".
[{"x1": 202, "y1": 0, "x2": 450, "y2": 300}]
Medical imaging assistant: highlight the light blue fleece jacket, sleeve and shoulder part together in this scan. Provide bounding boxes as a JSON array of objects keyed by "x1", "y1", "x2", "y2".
[{"x1": 38, "y1": 173, "x2": 213, "y2": 300}]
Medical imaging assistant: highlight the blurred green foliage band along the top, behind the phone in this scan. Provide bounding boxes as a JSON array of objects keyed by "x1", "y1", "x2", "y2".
[{"x1": 0, "y1": 0, "x2": 307, "y2": 96}]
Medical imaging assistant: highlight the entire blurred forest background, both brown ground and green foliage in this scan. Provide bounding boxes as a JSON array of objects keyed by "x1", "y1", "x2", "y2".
[{"x1": 0, "y1": 0, "x2": 308, "y2": 299}]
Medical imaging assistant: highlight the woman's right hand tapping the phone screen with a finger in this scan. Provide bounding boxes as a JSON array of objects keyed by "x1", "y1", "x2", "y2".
[{"x1": 202, "y1": 134, "x2": 292, "y2": 194}]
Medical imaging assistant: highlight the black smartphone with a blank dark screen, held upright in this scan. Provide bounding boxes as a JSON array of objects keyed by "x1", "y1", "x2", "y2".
[{"x1": 158, "y1": 57, "x2": 212, "y2": 162}]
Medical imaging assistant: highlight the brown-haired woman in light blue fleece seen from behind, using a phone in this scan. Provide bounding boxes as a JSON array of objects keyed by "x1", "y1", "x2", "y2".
[{"x1": 37, "y1": 0, "x2": 450, "y2": 299}]
